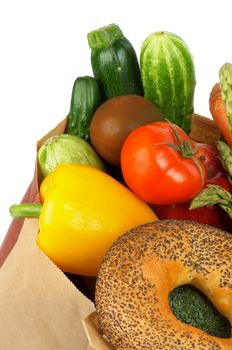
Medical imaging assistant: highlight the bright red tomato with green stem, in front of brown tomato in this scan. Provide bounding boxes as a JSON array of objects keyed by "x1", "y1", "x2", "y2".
[{"x1": 121, "y1": 122, "x2": 205, "y2": 205}]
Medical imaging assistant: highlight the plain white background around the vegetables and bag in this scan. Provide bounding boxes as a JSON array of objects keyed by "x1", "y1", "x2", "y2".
[{"x1": 0, "y1": 0, "x2": 232, "y2": 243}]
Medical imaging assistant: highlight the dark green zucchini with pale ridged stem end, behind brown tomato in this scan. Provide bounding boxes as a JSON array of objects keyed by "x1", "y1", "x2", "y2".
[{"x1": 88, "y1": 24, "x2": 143, "y2": 101}]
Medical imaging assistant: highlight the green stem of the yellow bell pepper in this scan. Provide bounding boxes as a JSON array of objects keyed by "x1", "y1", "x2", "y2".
[{"x1": 9, "y1": 203, "x2": 43, "y2": 219}]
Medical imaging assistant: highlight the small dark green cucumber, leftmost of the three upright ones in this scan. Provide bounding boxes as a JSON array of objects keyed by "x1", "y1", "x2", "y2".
[{"x1": 66, "y1": 76, "x2": 101, "y2": 142}]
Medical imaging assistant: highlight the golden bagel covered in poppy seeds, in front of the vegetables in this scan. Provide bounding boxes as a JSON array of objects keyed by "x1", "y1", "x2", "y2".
[{"x1": 95, "y1": 220, "x2": 232, "y2": 350}]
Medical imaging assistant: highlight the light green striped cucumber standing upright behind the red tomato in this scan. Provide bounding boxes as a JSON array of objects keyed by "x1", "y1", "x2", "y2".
[{"x1": 140, "y1": 32, "x2": 196, "y2": 134}]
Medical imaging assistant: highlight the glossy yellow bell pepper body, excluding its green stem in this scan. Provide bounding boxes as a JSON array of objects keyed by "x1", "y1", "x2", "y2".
[{"x1": 11, "y1": 163, "x2": 157, "y2": 276}]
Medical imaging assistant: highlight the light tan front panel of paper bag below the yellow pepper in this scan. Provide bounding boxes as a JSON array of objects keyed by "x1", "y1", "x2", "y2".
[{"x1": 0, "y1": 219, "x2": 94, "y2": 350}]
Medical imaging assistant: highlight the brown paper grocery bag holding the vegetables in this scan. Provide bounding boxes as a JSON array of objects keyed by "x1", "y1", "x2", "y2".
[{"x1": 0, "y1": 115, "x2": 221, "y2": 350}]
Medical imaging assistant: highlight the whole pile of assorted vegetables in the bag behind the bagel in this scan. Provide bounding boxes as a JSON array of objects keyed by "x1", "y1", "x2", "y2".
[{"x1": 10, "y1": 24, "x2": 232, "y2": 340}]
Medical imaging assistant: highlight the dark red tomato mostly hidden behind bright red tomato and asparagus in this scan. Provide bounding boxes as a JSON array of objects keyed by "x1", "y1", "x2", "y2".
[{"x1": 153, "y1": 143, "x2": 232, "y2": 230}]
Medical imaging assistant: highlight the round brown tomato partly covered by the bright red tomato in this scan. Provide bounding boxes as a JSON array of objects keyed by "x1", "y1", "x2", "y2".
[{"x1": 90, "y1": 95, "x2": 164, "y2": 166}]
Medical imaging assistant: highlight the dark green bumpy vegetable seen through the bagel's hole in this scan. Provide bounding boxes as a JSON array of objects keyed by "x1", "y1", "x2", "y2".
[{"x1": 168, "y1": 284, "x2": 231, "y2": 338}]
